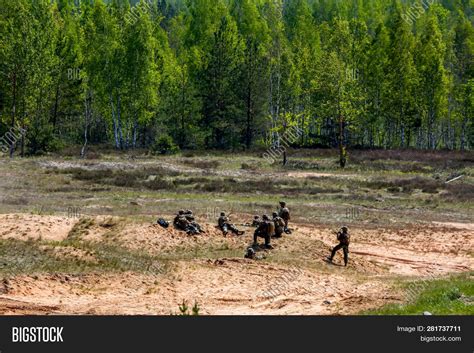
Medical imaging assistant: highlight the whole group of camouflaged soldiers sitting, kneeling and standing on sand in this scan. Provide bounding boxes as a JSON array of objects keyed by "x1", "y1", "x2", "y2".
[{"x1": 166, "y1": 201, "x2": 350, "y2": 266}]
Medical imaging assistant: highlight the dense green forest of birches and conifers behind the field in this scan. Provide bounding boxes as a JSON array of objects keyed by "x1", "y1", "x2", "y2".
[{"x1": 0, "y1": 0, "x2": 474, "y2": 157}]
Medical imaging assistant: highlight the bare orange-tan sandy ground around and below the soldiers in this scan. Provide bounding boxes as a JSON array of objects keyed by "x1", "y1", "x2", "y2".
[{"x1": 0, "y1": 214, "x2": 474, "y2": 315}]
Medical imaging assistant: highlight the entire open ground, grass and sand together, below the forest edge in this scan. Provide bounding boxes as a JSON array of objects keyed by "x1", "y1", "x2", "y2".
[{"x1": 0, "y1": 146, "x2": 474, "y2": 314}]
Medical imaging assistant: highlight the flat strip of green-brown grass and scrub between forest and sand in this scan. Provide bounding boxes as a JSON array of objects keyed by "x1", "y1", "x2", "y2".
[{"x1": 0, "y1": 150, "x2": 474, "y2": 224}]
